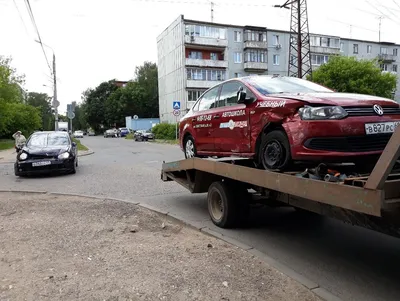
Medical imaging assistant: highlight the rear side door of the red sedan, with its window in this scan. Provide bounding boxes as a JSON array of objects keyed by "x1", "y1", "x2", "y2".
[{"x1": 192, "y1": 86, "x2": 220, "y2": 152}]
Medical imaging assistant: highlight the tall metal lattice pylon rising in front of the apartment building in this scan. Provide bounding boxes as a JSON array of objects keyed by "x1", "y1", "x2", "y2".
[{"x1": 274, "y1": 0, "x2": 312, "y2": 78}]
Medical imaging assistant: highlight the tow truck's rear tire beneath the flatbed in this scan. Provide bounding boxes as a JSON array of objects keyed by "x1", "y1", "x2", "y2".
[{"x1": 207, "y1": 181, "x2": 248, "y2": 228}]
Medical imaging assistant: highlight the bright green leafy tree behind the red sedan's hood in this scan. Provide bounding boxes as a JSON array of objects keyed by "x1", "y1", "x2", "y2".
[{"x1": 308, "y1": 56, "x2": 397, "y2": 98}]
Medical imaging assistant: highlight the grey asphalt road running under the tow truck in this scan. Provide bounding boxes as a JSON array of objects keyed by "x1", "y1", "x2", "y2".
[{"x1": 0, "y1": 137, "x2": 400, "y2": 301}]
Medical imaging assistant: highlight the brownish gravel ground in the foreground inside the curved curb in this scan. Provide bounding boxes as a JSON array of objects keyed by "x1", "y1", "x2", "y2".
[{"x1": 0, "y1": 193, "x2": 319, "y2": 301}]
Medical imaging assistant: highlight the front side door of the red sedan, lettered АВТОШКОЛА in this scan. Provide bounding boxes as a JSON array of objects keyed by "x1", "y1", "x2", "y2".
[{"x1": 215, "y1": 80, "x2": 251, "y2": 154}]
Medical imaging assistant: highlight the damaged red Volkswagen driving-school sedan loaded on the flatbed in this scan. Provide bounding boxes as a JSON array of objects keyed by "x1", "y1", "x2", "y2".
[{"x1": 179, "y1": 75, "x2": 400, "y2": 170}]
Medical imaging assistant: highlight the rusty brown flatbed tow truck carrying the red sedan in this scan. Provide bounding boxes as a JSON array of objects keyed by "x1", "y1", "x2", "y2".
[{"x1": 161, "y1": 127, "x2": 400, "y2": 238}]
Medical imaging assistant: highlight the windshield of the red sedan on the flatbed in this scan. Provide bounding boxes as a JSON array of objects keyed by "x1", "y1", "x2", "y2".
[{"x1": 243, "y1": 76, "x2": 334, "y2": 95}]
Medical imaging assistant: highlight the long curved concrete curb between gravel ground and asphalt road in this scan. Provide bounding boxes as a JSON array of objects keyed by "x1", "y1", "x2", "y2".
[{"x1": 0, "y1": 190, "x2": 343, "y2": 301}]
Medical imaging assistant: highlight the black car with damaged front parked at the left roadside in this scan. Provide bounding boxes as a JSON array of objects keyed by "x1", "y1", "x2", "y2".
[{"x1": 14, "y1": 132, "x2": 78, "y2": 176}]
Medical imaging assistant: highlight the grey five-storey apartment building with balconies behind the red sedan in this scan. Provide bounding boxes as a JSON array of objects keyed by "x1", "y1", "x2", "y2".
[{"x1": 157, "y1": 15, "x2": 400, "y2": 122}]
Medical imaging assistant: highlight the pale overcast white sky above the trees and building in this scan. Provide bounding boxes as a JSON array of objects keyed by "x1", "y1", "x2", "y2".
[{"x1": 0, "y1": 0, "x2": 400, "y2": 113}]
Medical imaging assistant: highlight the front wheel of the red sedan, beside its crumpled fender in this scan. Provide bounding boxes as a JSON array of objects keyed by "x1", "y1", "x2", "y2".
[{"x1": 258, "y1": 130, "x2": 292, "y2": 170}]
